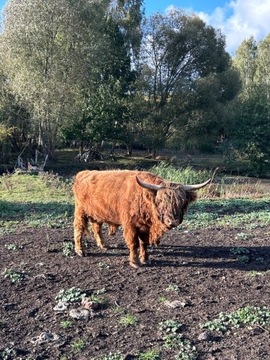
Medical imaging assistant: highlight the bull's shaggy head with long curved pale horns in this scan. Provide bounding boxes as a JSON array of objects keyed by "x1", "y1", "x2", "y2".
[{"x1": 136, "y1": 177, "x2": 211, "y2": 229}]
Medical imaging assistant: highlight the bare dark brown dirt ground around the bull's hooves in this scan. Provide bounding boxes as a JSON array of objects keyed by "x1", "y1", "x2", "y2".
[{"x1": 0, "y1": 225, "x2": 270, "y2": 360}]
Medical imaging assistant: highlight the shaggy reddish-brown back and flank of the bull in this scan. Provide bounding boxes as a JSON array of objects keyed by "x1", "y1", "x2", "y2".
[{"x1": 73, "y1": 170, "x2": 161, "y2": 225}]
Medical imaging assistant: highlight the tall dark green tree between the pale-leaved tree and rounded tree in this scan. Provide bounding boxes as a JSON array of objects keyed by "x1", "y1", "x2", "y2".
[{"x1": 60, "y1": 1, "x2": 141, "y2": 151}]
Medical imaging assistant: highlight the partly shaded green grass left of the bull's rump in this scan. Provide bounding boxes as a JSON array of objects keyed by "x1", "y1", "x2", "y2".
[{"x1": 0, "y1": 173, "x2": 73, "y2": 234}]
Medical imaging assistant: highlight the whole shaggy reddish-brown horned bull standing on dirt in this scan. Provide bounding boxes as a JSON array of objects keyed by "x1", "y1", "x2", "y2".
[{"x1": 73, "y1": 170, "x2": 210, "y2": 268}]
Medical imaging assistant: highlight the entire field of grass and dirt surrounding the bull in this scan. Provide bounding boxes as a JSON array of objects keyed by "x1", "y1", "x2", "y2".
[{"x1": 0, "y1": 159, "x2": 270, "y2": 360}]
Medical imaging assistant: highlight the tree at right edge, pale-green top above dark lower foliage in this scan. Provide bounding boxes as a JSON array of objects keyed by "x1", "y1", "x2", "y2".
[{"x1": 231, "y1": 35, "x2": 270, "y2": 176}]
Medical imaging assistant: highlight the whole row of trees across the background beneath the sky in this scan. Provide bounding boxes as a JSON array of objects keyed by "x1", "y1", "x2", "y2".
[{"x1": 0, "y1": 0, "x2": 270, "y2": 176}]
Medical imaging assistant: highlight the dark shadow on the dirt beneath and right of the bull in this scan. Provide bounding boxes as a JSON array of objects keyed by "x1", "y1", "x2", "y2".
[{"x1": 82, "y1": 242, "x2": 270, "y2": 272}]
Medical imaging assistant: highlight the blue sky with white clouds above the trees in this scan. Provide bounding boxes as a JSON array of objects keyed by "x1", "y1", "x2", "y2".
[{"x1": 0, "y1": 0, "x2": 270, "y2": 56}]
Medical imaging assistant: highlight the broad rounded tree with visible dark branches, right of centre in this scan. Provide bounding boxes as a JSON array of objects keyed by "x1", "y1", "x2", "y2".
[{"x1": 134, "y1": 10, "x2": 235, "y2": 153}]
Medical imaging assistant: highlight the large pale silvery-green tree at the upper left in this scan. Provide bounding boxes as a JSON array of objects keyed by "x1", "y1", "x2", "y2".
[{"x1": 1, "y1": 0, "x2": 110, "y2": 155}]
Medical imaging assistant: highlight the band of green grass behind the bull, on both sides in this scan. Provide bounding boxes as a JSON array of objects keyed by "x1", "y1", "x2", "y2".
[{"x1": 0, "y1": 163, "x2": 270, "y2": 233}]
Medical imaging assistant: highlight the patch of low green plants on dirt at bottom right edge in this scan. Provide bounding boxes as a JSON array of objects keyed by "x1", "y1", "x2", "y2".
[{"x1": 201, "y1": 306, "x2": 270, "y2": 332}]
